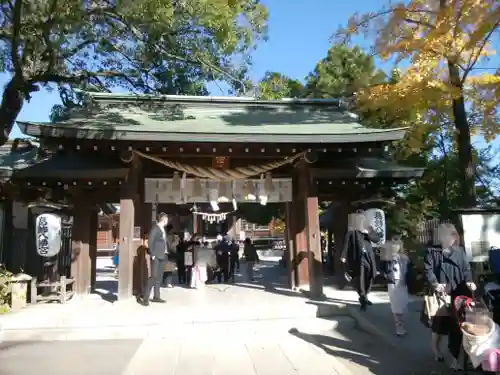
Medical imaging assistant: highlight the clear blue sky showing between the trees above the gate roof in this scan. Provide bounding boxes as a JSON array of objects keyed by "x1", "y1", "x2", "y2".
[{"x1": 0, "y1": 0, "x2": 498, "y2": 151}]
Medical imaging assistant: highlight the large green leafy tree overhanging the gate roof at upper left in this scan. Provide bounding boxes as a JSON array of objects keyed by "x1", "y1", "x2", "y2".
[{"x1": 0, "y1": 0, "x2": 267, "y2": 140}]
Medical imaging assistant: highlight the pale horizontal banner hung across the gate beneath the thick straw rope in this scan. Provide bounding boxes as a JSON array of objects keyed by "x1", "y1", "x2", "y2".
[{"x1": 144, "y1": 178, "x2": 292, "y2": 203}]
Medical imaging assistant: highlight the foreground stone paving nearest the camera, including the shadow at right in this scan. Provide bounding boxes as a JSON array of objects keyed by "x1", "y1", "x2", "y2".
[{"x1": 0, "y1": 317, "x2": 450, "y2": 375}]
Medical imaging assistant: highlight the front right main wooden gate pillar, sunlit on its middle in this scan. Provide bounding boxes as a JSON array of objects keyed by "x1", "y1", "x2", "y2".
[{"x1": 298, "y1": 161, "x2": 323, "y2": 298}]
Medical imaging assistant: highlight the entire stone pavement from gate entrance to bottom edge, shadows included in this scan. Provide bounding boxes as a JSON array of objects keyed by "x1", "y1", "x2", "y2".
[{"x1": 0, "y1": 262, "x2": 452, "y2": 375}]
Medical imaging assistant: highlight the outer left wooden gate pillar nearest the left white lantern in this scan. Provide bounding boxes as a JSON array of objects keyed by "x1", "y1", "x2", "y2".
[{"x1": 71, "y1": 206, "x2": 92, "y2": 296}]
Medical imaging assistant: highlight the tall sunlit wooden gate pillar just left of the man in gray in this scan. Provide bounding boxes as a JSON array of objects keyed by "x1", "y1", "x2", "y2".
[{"x1": 118, "y1": 158, "x2": 140, "y2": 300}]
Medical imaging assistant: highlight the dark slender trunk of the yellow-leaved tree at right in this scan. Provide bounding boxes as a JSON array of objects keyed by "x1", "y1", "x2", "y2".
[{"x1": 448, "y1": 62, "x2": 477, "y2": 208}]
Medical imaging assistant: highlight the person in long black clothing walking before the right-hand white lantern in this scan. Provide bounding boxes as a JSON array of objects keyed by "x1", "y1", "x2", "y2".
[{"x1": 340, "y1": 213, "x2": 380, "y2": 311}]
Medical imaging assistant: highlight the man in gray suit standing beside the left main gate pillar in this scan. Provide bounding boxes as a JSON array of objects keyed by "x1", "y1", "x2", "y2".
[{"x1": 140, "y1": 212, "x2": 168, "y2": 306}]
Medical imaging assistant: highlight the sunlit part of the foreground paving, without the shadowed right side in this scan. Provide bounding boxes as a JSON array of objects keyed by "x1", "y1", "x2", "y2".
[{"x1": 0, "y1": 319, "x2": 353, "y2": 375}]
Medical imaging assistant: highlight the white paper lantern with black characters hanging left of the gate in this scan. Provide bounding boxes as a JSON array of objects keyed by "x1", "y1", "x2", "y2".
[{"x1": 35, "y1": 214, "x2": 62, "y2": 258}]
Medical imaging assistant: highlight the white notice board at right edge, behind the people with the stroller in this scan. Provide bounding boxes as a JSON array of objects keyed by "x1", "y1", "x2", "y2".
[{"x1": 461, "y1": 212, "x2": 500, "y2": 262}]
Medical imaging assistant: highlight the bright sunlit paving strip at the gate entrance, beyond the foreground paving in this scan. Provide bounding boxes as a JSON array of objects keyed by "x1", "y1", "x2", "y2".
[{"x1": 0, "y1": 262, "x2": 340, "y2": 340}]
